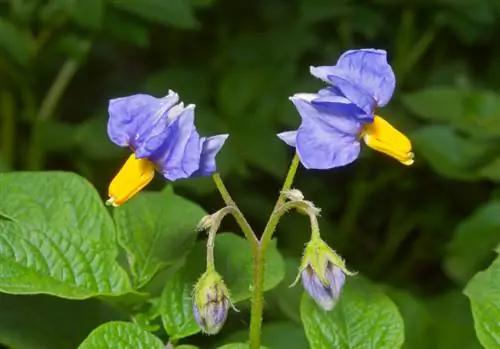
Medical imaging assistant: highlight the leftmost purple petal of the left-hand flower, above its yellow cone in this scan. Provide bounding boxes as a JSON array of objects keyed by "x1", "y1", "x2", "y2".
[{"x1": 108, "y1": 91, "x2": 179, "y2": 157}]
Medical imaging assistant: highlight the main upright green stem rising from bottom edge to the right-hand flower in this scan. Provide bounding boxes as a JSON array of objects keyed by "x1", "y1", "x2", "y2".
[{"x1": 250, "y1": 154, "x2": 299, "y2": 349}]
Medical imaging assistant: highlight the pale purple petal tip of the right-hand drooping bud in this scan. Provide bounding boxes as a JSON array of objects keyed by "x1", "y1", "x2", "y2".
[{"x1": 301, "y1": 262, "x2": 345, "y2": 310}]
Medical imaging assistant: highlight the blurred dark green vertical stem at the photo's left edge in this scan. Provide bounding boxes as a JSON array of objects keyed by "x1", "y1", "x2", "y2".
[{"x1": 0, "y1": 91, "x2": 15, "y2": 168}]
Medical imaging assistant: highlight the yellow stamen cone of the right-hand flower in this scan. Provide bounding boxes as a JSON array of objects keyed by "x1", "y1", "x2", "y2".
[{"x1": 362, "y1": 115, "x2": 414, "y2": 166}]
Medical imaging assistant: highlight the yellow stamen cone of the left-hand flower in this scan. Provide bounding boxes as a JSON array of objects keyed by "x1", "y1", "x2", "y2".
[{"x1": 106, "y1": 154, "x2": 155, "y2": 207}]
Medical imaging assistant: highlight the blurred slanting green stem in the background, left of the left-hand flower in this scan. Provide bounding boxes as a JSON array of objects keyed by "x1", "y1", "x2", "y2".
[{"x1": 27, "y1": 42, "x2": 90, "y2": 170}]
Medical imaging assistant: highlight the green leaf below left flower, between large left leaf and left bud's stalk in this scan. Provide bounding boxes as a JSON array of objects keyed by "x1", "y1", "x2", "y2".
[{"x1": 114, "y1": 187, "x2": 207, "y2": 287}]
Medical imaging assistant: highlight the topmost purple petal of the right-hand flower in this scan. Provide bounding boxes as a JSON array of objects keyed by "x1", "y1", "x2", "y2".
[{"x1": 311, "y1": 49, "x2": 396, "y2": 106}]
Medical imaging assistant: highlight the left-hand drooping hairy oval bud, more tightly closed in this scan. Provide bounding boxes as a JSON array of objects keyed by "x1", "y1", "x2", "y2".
[{"x1": 193, "y1": 271, "x2": 231, "y2": 334}]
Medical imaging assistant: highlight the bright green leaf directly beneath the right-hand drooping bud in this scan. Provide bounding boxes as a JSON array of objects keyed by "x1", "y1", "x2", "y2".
[{"x1": 301, "y1": 277, "x2": 404, "y2": 349}]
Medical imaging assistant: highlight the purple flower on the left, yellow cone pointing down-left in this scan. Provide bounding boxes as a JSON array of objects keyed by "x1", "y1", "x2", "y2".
[{"x1": 108, "y1": 91, "x2": 228, "y2": 206}]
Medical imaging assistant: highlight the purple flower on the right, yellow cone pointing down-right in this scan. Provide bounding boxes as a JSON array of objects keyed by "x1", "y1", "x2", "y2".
[{"x1": 278, "y1": 49, "x2": 413, "y2": 169}]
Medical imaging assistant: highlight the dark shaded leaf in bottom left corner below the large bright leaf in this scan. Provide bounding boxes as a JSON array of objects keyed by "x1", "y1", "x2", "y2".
[{"x1": 0, "y1": 294, "x2": 126, "y2": 349}]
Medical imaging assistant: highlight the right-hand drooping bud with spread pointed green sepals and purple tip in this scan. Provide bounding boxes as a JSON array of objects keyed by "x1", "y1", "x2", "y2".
[{"x1": 294, "y1": 236, "x2": 354, "y2": 310}]
